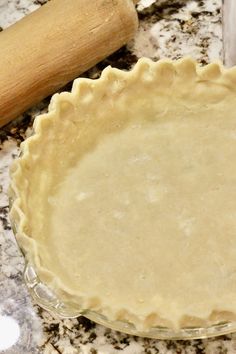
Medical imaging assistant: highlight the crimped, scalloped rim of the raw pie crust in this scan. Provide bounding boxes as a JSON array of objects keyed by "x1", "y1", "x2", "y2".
[{"x1": 9, "y1": 58, "x2": 236, "y2": 330}]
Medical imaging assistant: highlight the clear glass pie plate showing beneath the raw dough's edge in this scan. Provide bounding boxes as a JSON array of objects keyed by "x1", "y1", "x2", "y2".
[{"x1": 9, "y1": 189, "x2": 236, "y2": 340}]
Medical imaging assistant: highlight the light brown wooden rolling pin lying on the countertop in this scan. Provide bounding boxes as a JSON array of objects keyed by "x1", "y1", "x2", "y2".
[{"x1": 0, "y1": 0, "x2": 138, "y2": 127}]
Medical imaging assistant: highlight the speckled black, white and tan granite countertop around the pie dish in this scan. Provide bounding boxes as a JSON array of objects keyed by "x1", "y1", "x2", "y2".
[{"x1": 0, "y1": 0, "x2": 233, "y2": 354}]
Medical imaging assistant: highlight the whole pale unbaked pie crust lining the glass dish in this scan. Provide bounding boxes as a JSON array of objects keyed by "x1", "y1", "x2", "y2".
[{"x1": 11, "y1": 59, "x2": 236, "y2": 330}]
